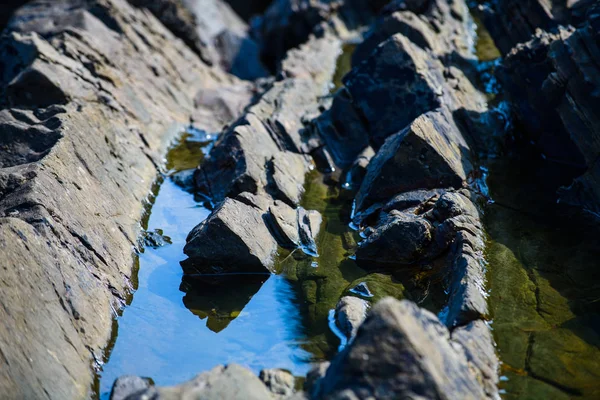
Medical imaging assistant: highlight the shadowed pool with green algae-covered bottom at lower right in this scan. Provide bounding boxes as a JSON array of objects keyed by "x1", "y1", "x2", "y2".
[{"x1": 485, "y1": 155, "x2": 600, "y2": 399}]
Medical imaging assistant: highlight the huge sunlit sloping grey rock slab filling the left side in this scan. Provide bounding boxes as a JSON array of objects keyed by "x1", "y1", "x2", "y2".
[{"x1": 0, "y1": 0, "x2": 250, "y2": 399}]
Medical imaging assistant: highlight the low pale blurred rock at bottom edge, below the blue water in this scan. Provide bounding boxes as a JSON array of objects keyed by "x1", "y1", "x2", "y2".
[{"x1": 128, "y1": 364, "x2": 273, "y2": 400}]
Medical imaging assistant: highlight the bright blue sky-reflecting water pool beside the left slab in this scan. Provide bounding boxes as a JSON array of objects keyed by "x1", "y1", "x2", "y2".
[{"x1": 99, "y1": 179, "x2": 311, "y2": 399}]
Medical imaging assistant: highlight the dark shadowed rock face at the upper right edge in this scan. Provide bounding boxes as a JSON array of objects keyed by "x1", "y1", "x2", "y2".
[{"x1": 499, "y1": 11, "x2": 600, "y2": 219}]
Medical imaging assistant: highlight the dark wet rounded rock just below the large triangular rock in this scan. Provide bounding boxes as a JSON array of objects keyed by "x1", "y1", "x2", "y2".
[{"x1": 356, "y1": 211, "x2": 433, "y2": 268}]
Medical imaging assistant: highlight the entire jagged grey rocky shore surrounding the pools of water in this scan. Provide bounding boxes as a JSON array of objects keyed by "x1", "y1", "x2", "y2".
[{"x1": 0, "y1": 0, "x2": 600, "y2": 400}]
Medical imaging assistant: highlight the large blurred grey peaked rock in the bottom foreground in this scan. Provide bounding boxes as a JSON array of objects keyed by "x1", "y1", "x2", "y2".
[{"x1": 314, "y1": 298, "x2": 486, "y2": 399}]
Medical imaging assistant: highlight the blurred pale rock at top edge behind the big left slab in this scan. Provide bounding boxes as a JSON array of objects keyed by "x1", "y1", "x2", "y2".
[{"x1": 128, "y1": 0, "x2": 268, "y2": 79}]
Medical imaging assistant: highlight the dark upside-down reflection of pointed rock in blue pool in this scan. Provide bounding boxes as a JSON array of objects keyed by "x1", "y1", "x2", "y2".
[{"x1": 179, "y1": 274, "x2": 269, "y2": 333}]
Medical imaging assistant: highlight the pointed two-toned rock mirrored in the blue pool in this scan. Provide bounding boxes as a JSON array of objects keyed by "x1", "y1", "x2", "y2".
[{"x1": 183, "y1": 198, "x2": 277, "y2": 272}]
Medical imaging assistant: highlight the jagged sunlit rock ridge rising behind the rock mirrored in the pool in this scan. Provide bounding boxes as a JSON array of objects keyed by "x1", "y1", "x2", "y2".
[{"x1": 195, "y1": 36, "x2": 341, "y2": 205}]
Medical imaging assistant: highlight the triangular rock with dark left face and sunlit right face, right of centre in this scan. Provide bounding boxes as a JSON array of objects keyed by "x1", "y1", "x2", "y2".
[{"x1": 356, "y1": 106, "x2": 473, "y2": 212}]
